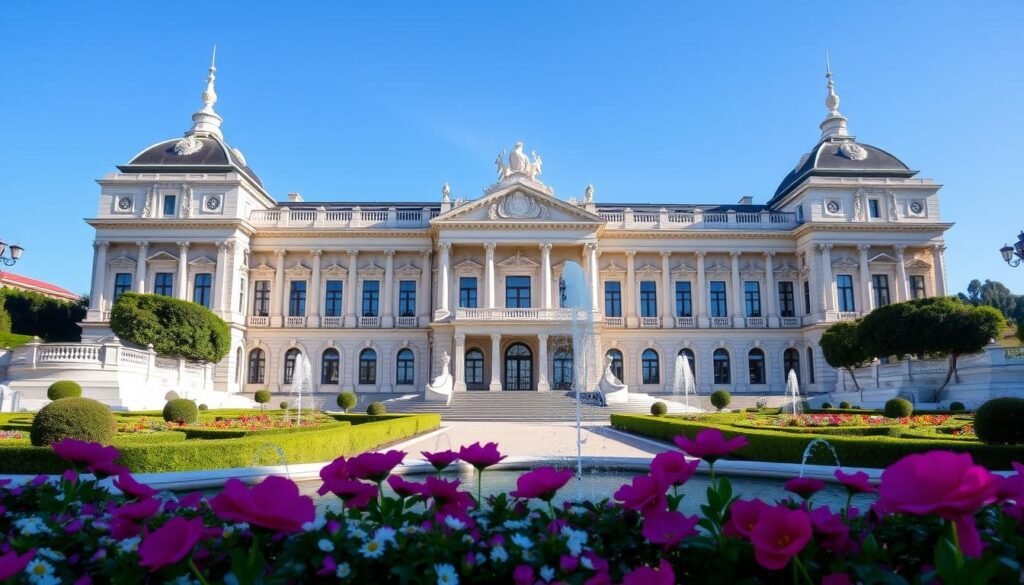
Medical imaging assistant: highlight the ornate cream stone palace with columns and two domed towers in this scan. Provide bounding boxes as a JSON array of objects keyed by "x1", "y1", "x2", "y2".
[{"x1": 82, "y1": 60, "x2": 950, "y2": 395}]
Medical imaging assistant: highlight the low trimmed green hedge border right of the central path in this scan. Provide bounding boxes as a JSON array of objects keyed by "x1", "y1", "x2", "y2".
[{"x1": 611, "y1": 414, "x2": 1024, "y2": 469}]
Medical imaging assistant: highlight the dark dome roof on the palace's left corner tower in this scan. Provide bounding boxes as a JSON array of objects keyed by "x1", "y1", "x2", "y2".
[{"x1": 118, "y1": 135, "x2": 263, "y2": 186}]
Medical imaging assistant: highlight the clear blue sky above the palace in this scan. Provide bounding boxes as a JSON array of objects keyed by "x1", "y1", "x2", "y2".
[{"x1": 0, "y1": 0, "x2": 1024, "y2": 293}]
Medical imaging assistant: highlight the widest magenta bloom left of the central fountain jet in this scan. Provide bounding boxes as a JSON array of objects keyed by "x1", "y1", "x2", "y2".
[{"x1": 210, "y1": 476, "x2": 316, "y2": 533}]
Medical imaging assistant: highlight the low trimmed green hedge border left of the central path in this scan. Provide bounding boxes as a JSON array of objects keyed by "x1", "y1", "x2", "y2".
[{"x1": 0, "y1": 414, "x2": 441, "y2": 473}]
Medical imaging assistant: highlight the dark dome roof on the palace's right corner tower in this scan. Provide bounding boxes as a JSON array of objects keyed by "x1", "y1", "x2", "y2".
[{"x1": 768, "y1": 137, "x2": 918, "y2": 205}]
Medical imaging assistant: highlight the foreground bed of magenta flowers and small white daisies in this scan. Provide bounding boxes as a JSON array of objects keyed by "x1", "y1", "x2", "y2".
[{"x1": 0, "y1": 434, "x2": 1024, "y2": 585}]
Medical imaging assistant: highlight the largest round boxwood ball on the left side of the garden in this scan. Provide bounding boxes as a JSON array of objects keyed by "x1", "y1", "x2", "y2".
[{"x1": 30, "y1": 398, "x2": 117, "y2": 447}]
